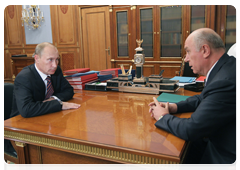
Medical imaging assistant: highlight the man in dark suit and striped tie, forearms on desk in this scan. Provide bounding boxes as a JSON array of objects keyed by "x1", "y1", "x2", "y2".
[{"x1": 11, "y1": 42, "x2": 80, "y2": 118}]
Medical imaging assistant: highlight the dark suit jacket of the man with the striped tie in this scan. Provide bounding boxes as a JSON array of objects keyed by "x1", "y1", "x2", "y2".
[{"x1": 11, "y1": 64, "x2": 74, "y2": 117}]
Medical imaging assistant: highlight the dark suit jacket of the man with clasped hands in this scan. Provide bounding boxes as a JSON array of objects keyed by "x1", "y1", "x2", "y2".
[{"x1": 155, "y1": 54, "x2": 238, "y2": 170}]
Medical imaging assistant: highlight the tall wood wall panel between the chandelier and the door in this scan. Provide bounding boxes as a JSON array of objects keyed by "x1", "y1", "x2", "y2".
[{"x1": 50, "y1": 5, "x2": 82, "y2": 71}]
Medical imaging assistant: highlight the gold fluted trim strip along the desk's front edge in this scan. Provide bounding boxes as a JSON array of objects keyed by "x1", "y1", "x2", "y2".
[{"x1": 4, "y1": 130, "x2": 182, "y2": 170}]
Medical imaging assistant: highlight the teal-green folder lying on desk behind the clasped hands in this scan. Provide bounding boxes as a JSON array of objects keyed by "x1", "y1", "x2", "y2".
[{"x1": 157, "y1": 93, "x2": 190, "y2": 103}]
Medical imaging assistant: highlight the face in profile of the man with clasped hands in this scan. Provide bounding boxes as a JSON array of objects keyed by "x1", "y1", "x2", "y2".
[{"x1": 184, "y1": 37, "x2": 203, "y2": 74}]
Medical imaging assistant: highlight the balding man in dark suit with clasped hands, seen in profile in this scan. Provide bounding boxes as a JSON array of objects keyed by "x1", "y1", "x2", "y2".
[{"x1": 149, "y1": 28, "x2": 238, "y2": 170}]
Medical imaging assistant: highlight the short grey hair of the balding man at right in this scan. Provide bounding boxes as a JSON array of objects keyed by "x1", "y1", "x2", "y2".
[{"x1": 194, "y1": 30, "x2": 225, "y2": 51}]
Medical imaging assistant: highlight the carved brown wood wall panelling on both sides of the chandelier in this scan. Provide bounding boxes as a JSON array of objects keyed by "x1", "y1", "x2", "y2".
[{"x1": 4, "y1": 5, "x2": 83, "y2": 80}]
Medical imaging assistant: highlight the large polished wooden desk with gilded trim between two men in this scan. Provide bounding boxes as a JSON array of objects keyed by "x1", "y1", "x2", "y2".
[{"x1": 4, "y1": 89, "x2": 200, "y2": 170}]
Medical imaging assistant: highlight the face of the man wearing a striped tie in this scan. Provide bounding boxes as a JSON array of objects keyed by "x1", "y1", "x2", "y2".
[{"x1": 35, "y1": 46, "x2": 59, "y2": 75}]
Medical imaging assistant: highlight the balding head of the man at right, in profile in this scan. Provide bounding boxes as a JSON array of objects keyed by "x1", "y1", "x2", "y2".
[{"x1": 184, "y1": 28, "x2": 225, "y2": 75}]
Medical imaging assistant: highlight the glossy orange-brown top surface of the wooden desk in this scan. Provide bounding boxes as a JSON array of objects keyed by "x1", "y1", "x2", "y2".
[{"x1": 4, "y1": 89, "x2": 200, "y2": 165}]
